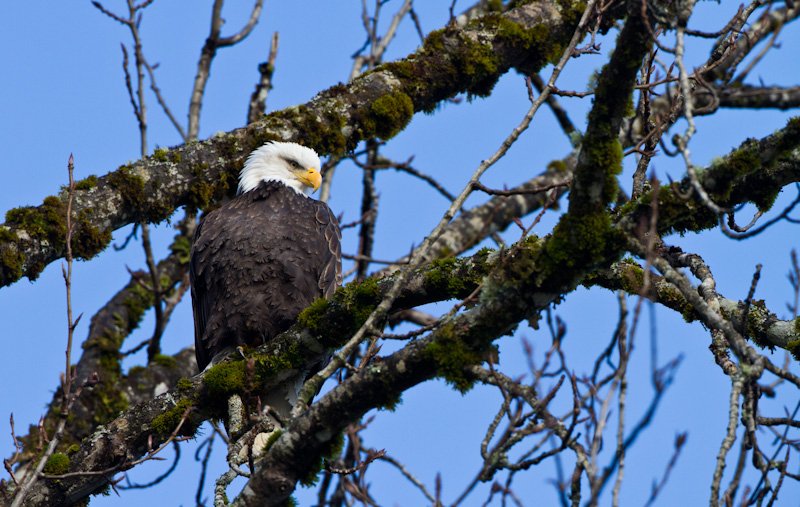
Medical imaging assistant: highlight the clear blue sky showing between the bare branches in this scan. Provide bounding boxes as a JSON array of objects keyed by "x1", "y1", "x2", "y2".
[{"x1": 0, "y1": 0, "x2": 800, "y2": 505}]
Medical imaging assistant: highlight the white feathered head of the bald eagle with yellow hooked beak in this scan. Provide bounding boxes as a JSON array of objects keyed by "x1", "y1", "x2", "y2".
[{"x1": 238, "y1": 142, "x2": 322, "y2": 197}]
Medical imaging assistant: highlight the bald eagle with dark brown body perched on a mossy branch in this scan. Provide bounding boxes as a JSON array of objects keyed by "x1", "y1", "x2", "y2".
[{"x1": 189, "y1": 142, "x2": 342, "y2": 412}]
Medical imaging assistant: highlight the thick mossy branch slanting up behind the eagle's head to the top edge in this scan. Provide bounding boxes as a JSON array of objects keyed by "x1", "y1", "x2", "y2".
[{"x1": 0, "y1": 0, "x2": 613, "y2": 287}]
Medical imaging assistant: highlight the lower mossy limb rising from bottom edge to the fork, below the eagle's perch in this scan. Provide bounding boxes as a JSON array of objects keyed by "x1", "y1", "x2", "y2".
[{"x1": 233, "y1": 254, "x2": 572, "y2": 507}]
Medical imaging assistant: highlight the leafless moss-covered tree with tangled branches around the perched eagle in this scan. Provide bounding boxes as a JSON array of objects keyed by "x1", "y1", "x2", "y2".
[{"x1": 0, "y1": 0, "x2": 800, "y2": 506}]
